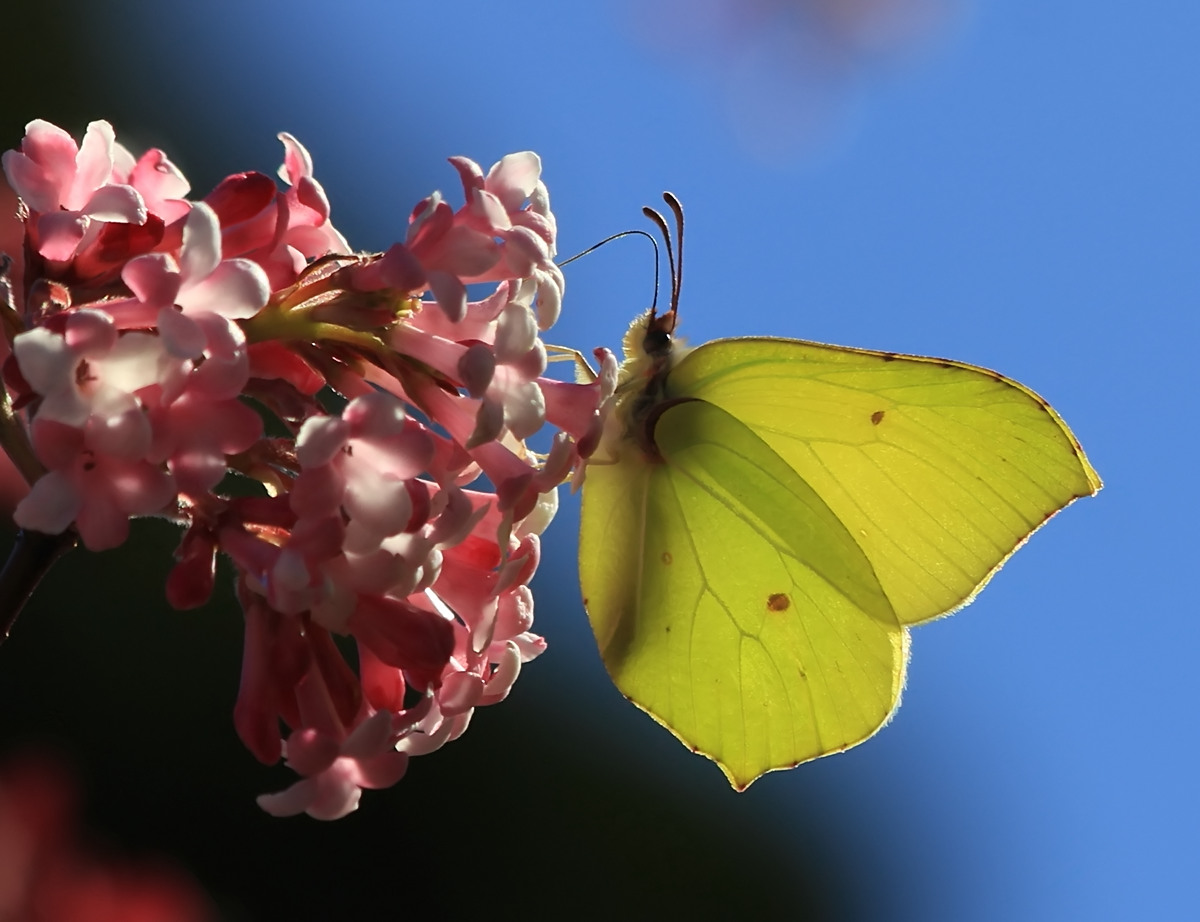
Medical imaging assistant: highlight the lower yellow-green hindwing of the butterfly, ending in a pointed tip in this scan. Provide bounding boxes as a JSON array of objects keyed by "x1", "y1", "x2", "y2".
[{"x1": 580, "y1": 396, "x2": 908, "y2": 789}]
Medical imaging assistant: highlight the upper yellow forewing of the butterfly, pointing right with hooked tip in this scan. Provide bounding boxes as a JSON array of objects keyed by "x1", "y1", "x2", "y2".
[{"x1": 668, "y1": 339, "x2": 1100, "y2": 624}]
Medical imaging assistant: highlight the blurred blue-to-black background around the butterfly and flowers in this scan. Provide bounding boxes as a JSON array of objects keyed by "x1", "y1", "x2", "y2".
[{"x1": 0, "y1": 0, "x2": 1200, "y2": 921}]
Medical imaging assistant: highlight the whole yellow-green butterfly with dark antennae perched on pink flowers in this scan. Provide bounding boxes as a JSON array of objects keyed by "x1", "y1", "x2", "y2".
[{"x1": 580, "y1": 193, "x2": 1100, "y2": 790}]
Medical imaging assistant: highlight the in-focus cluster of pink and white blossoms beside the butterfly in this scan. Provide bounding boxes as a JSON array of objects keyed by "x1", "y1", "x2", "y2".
[{"x1": 2, "y1": 121, "x2": 614, "y2": 819}]
